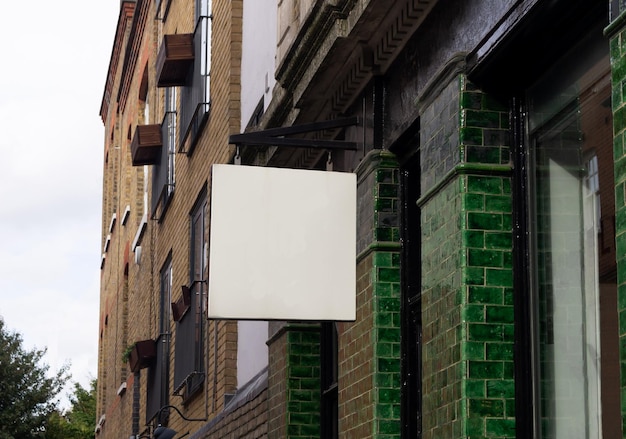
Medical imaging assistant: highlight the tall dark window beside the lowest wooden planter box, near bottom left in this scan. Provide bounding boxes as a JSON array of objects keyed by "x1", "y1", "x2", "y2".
[{"x1": 146, "y1": 255, "x2": 172, "y2": 422}]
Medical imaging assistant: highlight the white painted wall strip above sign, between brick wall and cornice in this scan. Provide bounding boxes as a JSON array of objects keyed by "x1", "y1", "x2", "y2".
[{"x1": 241, "y1": 0, "x2": 278, "y2": 131}]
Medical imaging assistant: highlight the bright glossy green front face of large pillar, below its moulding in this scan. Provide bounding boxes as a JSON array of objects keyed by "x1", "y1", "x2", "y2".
[{"x1": 460, "y1": 175, "x2": 515, "y2": 438}]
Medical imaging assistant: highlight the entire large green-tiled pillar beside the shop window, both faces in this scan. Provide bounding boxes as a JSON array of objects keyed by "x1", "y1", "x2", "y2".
[{"x1": 421, "y1": 77, "x2": 515, "y2": 439}]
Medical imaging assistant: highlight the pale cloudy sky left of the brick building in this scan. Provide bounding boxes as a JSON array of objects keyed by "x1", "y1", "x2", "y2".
[{"x1": 0, "y1": 0, "x2": 120, "y2": 408}]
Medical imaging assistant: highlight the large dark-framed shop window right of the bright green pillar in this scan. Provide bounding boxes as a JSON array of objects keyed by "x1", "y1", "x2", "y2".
[{"x1": 525, "y1": 18, "x2": 622, "y2": 439}]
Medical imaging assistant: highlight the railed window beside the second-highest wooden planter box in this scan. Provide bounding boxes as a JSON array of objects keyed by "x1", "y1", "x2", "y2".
[{"x1": 152, "y1": 87, "x2": 177, "y2": 221}]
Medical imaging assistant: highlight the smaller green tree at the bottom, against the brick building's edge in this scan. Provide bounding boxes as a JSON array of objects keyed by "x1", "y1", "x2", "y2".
[{"x1": 46, "y1": 380, "x2": 96, "y2": 439}]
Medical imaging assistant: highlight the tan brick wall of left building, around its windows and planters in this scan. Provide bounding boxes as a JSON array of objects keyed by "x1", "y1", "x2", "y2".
[{"x1": 97, "y1": 0, "x2": 244, "y2": 438}]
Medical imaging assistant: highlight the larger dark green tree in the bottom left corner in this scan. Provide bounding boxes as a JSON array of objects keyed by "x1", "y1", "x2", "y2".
[{"x1": 0, "y1": 318, "x2": 69, "y2": 439}]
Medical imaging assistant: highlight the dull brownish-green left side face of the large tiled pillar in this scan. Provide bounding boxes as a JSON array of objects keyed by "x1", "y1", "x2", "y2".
[{"x1": 422, "y1": 180, "x2": 466, "y2": 439}]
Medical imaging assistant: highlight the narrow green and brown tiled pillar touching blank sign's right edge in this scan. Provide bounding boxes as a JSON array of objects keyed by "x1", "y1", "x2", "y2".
[{"x1": 339, "y1": 150, "x2": 400, "y2": 439}]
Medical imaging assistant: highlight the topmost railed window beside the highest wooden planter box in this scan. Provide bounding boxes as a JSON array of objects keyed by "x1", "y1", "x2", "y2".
[{"x1": 180, "y1": 0, "x2": 212, "y2": 155}]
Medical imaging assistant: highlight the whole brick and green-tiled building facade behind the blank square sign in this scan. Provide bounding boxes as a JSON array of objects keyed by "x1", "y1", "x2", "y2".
[{"x1": 96, "y1": 0, "x2": 626, "y2": 439}]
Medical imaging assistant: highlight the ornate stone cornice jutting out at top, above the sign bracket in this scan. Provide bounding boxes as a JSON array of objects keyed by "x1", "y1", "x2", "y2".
[{"x1": 276, "y1": 0, "x2": 437, "y2": 121}]
